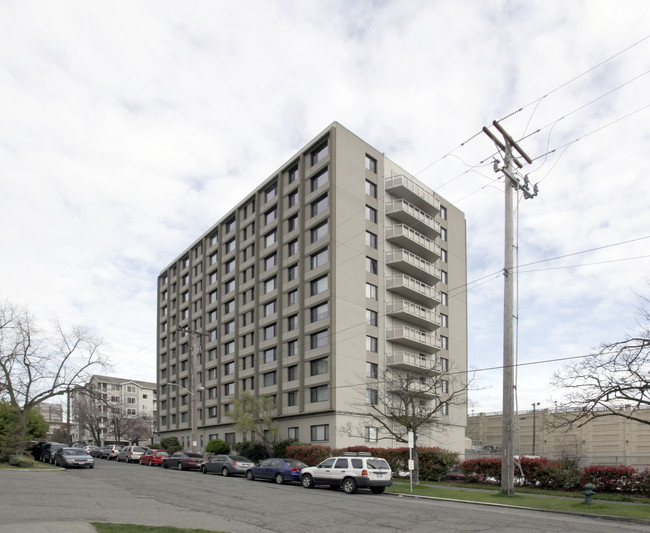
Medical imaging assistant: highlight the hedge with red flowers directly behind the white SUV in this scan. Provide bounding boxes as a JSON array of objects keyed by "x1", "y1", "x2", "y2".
[{"x1": 286, "y1": 446, "x2": 458, "y2": 481}]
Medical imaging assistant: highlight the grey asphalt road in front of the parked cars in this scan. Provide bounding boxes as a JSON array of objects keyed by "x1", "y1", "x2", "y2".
[{"x1": 0, "y1": 460, "x2": 650, "y2": 533}]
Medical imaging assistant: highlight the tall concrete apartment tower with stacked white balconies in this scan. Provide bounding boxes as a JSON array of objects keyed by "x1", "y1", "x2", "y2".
[{"x1": 157, "y1": 123, "x2": 467, "y2": 451}]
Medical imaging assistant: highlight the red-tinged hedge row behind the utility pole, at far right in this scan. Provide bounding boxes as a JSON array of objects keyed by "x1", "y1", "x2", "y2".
[{"x1": 460, "y1": 457, "x2": 650, "y2": 494}]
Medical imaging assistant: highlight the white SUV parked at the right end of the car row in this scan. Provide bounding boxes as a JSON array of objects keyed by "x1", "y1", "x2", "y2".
[{"x1": 300, "y1": 452, "x2": 393, "y2": 494}]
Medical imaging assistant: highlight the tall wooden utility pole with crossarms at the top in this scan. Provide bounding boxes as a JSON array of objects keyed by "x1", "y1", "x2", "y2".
[{"x1": 483, "y1": 120, "x2": 538, "y2": 495}]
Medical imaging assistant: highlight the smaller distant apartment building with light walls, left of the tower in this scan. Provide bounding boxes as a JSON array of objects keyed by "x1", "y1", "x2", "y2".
[{"x1": 71, "y1": 375, "x2": 158, "y2": 445}]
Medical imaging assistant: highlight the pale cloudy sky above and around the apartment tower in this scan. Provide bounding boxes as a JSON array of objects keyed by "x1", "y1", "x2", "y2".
[{"x1": 0, "y1": 0, "x2": 650, "y2": 412}]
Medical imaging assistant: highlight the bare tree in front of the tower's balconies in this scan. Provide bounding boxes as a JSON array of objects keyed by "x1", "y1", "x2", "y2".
[{"x1": 346, "y1": 368, "x2": 472, "y2": 483}]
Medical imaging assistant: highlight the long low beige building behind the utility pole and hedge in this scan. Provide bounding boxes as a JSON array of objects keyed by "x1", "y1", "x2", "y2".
[{"x1": 466, "y1": 408, "x2": 650, "y2": 468}]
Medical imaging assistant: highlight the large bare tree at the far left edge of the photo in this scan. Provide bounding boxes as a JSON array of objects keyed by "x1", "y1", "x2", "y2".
[{"x1": 0, "y1": 302, "x2": 105, "y2": 453}]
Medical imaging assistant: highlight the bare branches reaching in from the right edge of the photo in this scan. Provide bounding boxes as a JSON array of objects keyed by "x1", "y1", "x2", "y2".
[{"x1": 552, "y1": 286, "x2": 650, "y2": 427}]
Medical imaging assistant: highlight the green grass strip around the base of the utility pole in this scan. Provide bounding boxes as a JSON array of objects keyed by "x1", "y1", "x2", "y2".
[{"x1": 388, "y1": 482, "x2": 650, "y2": 520}]
